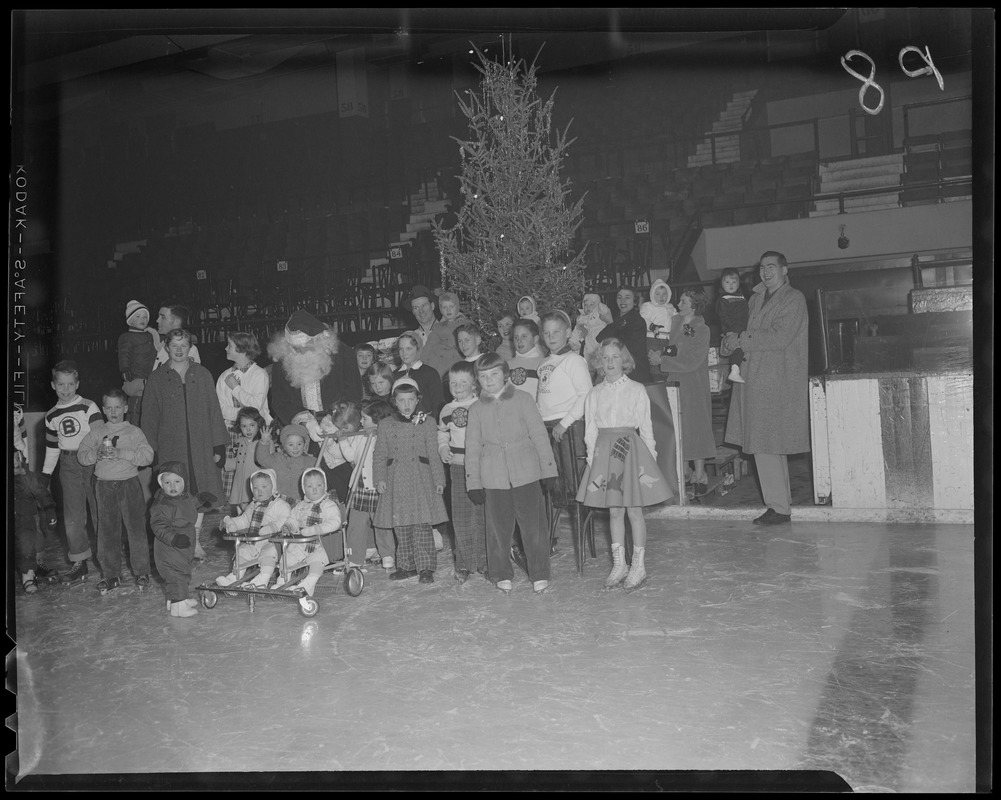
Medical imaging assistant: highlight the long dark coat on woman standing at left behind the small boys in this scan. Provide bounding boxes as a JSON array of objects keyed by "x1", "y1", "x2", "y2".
[{"x1": 140, "y1": 362, "x2": 229, "y2": 501}]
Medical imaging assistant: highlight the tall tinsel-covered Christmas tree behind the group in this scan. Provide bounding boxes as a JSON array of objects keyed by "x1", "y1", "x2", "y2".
[{"x1": 434, "y1": 43, "x2": 584, "y2": 329}]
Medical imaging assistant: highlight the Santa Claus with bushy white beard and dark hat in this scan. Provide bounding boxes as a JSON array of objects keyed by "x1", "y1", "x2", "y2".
[{"x1": 267, "y1": 309, "x2": 361, "y2": 441}]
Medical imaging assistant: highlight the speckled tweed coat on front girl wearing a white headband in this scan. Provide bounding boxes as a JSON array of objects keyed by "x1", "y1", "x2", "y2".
[{"x1": 372, "y1": 412, "x2": 448, "y2": 528}]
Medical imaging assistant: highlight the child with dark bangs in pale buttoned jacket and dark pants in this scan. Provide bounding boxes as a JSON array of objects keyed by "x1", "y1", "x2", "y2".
[{"x1": 465, "y1": 352, "x2": 557, "y2": 594}]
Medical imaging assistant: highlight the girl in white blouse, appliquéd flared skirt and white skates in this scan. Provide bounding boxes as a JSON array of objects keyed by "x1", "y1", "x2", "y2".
[{"x1": 577, "y1": 337, "x2": 672, "y2": 592}]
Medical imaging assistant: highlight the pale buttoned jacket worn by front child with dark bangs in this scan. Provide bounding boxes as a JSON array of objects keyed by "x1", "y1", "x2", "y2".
[{"x1": 465, "y1": 381, "x2": 557, "y2": 489}]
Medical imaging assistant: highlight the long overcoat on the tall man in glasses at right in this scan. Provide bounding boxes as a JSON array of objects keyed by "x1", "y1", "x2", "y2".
[{"x1": 728, "y1": 281, "x2": 810, "y2": 455}]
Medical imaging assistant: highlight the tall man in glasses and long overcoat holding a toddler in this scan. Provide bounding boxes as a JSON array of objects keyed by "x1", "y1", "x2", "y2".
[{"x1": 723, "y1": 250, "x2": 810, "y2": 525}]
